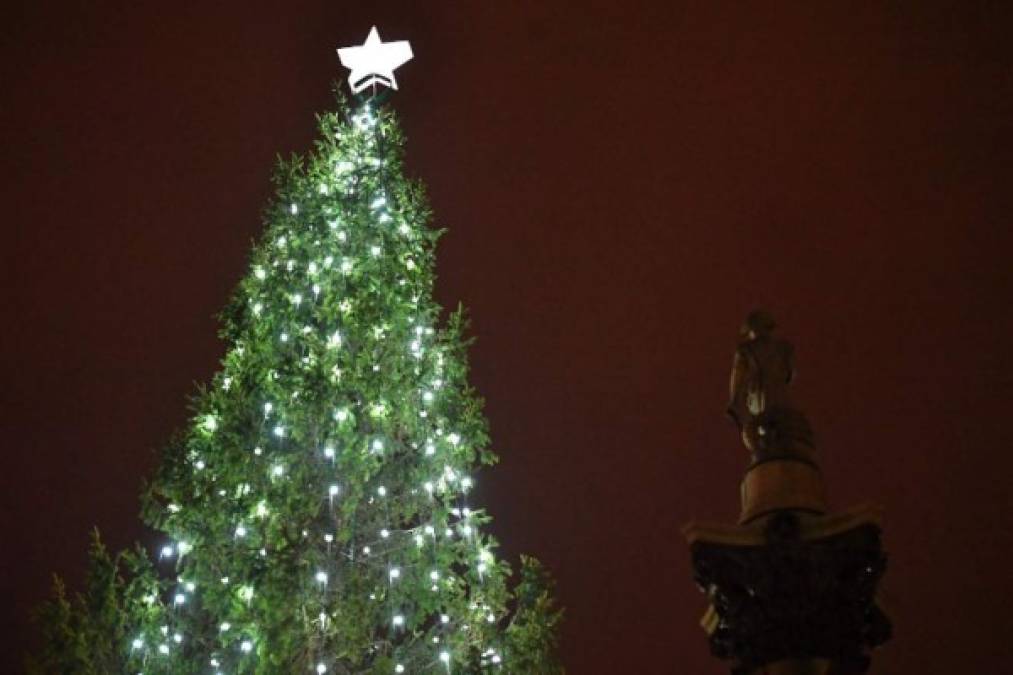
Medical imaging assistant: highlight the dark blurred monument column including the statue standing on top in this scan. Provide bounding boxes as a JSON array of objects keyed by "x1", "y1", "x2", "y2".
[{"x1": 684, "y1": 311, "x2": 891, "y2": 675}]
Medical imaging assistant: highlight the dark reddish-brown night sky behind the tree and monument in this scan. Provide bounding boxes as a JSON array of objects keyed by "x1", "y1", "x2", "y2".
[{"x1": 0, "y1": 0, "x2": 1013, "y2": 675}]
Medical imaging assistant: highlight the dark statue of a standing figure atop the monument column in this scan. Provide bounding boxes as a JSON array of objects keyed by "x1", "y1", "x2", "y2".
[{"x1": 727, "y1": 310, "x2": 812, "y2": 461}]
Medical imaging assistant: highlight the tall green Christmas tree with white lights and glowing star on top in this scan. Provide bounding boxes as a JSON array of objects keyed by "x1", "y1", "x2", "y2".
[{"x1": 29, "y1": 29, "x2": 561, "y2": 675}]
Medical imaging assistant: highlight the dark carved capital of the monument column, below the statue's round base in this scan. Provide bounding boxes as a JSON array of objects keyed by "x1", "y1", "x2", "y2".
[{"x1": 685, "y1": 507, "x2": 890, "y2": 675}]
